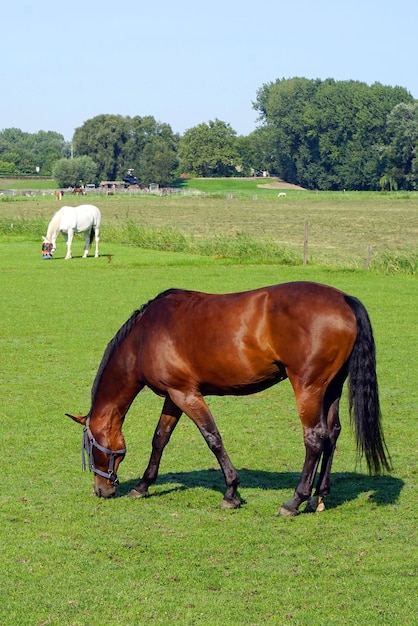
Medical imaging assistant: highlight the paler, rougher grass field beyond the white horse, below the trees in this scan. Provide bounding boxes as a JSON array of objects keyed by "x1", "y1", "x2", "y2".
[{"x1": 0, "y1": 179, "x2": 418, "y2": 273}]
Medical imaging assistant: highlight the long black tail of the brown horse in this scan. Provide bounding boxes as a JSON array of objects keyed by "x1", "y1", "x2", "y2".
[{"x1": 345, "y1": 296, "x2": 391, "y2": 474}]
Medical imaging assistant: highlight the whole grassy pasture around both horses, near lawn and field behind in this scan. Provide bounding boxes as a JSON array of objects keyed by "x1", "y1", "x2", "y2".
[{"x1": 0, "y1": 191, "x2": 418, "y2": 626}]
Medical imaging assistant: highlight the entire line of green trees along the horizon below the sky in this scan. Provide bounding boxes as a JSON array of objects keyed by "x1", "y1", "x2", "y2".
[{"x1": 0, "y1": 78, "x2": 418, "y2": 190}]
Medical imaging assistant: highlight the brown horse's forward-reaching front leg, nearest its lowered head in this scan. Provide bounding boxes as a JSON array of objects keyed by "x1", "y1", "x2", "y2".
[{"x1": 129, "y1": 398, "x2": 182, "y2": 498}]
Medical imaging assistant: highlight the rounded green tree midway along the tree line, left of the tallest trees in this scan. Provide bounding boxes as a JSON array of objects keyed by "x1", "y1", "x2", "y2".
[{"x1": 179, "y1": 119, "x2": 241, "y2": 177}]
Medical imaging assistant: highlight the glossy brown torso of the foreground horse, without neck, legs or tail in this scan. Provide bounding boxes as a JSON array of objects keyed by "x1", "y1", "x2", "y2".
[{"x1": 139, "y1": 282, "x2": 356, "y2": 393}]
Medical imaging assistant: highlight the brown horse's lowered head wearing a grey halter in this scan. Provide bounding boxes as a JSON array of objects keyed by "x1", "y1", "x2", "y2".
[{"x1": 67, "y1": 413, "x2": 126, "y2": 498}]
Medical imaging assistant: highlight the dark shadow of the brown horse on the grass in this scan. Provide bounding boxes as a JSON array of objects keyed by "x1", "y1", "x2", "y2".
[{"x1": 118, "y1": 468, "x2": 404, "y2": 509}]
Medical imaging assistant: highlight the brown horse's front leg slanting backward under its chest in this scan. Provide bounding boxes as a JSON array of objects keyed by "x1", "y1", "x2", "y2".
[{"x1": 166, "y1": 390, "x2": 241, "y2": 509}]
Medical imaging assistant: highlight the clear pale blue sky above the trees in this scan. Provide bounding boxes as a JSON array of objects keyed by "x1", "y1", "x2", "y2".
[{"x1": 0, "y1": 0, "x2": 418, "y2": 140}]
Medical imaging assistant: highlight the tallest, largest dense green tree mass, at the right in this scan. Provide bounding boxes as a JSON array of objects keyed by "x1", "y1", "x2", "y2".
[{"x1": 254, "y1": 78, "x2": 413, "y2": 189}]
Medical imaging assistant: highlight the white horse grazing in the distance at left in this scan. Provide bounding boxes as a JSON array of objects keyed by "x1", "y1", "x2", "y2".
[{"x1": 42, "y1": 204, "x2": 102, "y2": 259}]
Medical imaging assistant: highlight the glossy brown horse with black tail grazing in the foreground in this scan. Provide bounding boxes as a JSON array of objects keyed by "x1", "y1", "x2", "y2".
[{"x1": 69, "y1": 282, "x2": 390, "y2": 515}]
